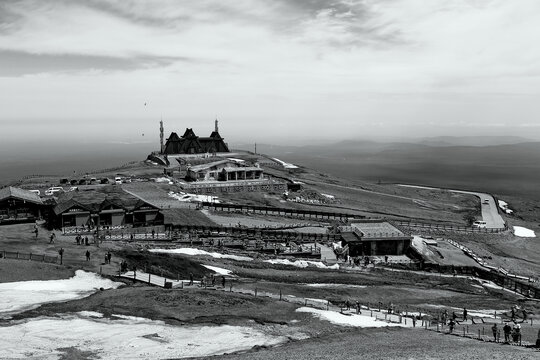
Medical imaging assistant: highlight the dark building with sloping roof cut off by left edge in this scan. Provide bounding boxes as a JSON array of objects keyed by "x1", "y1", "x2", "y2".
[{"x1": 0, "y1": 186, "x2": 44, "y2": 224}]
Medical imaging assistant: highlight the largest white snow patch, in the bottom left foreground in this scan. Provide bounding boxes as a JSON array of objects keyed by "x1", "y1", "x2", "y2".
[{"x1": 0, "y1": 315, "x2": 287, "y2": 359}]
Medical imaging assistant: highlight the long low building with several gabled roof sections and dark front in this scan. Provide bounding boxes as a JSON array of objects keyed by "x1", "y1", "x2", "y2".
[{"x1": 53, "y1": 186, "x2": 163, "y2": 230}]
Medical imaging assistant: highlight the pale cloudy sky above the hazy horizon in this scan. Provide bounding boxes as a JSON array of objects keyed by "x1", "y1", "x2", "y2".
[{"x1": 0, "y1": 0, "x2": 540, "y2": 148}]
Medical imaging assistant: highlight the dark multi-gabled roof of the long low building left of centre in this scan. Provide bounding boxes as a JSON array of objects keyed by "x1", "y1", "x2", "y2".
[{"x1": 54, "y1": 186, "x2": 156, "y2": 215}]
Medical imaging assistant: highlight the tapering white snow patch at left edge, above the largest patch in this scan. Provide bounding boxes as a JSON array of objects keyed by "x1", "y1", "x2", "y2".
[{"x1": 0, "y1": 270, "x2": 122, "y2": 317}]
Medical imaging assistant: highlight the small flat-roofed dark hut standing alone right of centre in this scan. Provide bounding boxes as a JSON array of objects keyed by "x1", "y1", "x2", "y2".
[{"x1": 342, "y1": 220, "x2": 412, "y2": 257}]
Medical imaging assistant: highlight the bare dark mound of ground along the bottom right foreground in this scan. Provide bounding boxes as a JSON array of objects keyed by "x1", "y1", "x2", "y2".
[{"x1": 218, "y1": 329, "x2": 540, "y2": 360}]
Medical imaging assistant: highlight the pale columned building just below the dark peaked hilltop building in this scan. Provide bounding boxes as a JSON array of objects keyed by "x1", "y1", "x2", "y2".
[{"x1": 186, "y1": 159, "x2": 263, "y2": 181}]
